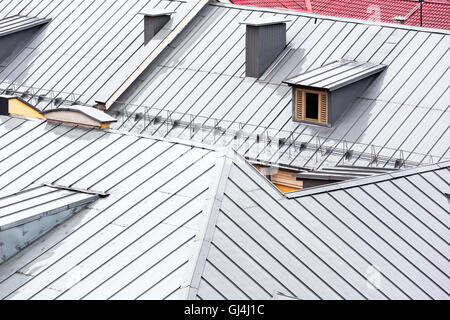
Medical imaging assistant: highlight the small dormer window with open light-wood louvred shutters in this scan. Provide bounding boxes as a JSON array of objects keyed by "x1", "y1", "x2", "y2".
[{"x1": 294, "y1": 88, "x2": 328, "y2": 125}]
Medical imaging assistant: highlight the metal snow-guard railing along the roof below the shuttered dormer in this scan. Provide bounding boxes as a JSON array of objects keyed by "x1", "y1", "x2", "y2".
[{"x1": 111, "y1": 102, "x2": 433, "y2": 168}]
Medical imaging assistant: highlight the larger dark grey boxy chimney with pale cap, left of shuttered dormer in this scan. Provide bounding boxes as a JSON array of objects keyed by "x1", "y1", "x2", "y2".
[{"x1": 241, "y1": 17, "x2": 289, "y2": 78}]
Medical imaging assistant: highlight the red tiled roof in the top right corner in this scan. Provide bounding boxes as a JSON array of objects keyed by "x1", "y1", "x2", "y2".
[{"x1": 232, "y1": 0, "x2": 450, "y2": 30}]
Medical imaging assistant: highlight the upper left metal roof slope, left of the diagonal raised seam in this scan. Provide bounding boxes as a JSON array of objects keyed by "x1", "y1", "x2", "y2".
[{"x1": 0, "y1": 0, "x2": 207, "y2": 110}]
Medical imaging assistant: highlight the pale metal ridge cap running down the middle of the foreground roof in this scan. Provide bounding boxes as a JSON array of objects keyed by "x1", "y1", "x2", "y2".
[{"x1": 181, "y1": 147, "x2": 236, "y2": 300}]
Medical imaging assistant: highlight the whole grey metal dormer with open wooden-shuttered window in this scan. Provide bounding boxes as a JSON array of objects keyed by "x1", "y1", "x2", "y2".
[{"x1": 283, "y1": 60, "x2": 386, "y2": 127}]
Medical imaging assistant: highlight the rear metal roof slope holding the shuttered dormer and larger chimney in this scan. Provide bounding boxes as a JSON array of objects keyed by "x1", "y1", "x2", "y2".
[{"x1": 111, "y1": 3, "x2": 450, "y2": 169}]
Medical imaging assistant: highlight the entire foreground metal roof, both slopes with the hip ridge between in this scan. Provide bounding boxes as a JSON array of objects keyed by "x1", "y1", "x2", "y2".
[{"x1": 0, "y1": 116, "x2": 450, "y2": 299}]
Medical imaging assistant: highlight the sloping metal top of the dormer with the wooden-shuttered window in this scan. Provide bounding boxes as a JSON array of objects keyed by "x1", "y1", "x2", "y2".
[{"x1": 284, "y1": 60, "x2": 387, "y2": 91}]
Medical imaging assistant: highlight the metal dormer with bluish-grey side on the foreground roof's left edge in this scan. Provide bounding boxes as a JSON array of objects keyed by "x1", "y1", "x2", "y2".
[{"x1": 0, "y1": 186, "x2": 98, "y2": 263}]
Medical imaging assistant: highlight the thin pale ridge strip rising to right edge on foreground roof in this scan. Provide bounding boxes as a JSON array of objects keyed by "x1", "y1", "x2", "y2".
[{"x1": 286, "y1": 161, "x2": 450, "y2": 199}]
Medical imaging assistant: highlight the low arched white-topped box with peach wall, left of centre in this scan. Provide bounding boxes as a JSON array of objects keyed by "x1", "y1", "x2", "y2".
[{"x1": 42, "y1": 105, "x2": 117, "y2": 128}]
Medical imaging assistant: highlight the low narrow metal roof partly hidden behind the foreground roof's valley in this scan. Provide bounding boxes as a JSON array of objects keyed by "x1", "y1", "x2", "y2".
[{"x1": 294, "y1": 166, "x2": 397, "y2": 181}]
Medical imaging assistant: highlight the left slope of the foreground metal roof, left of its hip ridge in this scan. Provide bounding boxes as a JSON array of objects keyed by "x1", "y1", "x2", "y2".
[{"x1": 0, "y1": 116, "x2": 218, "y2": 299}]
